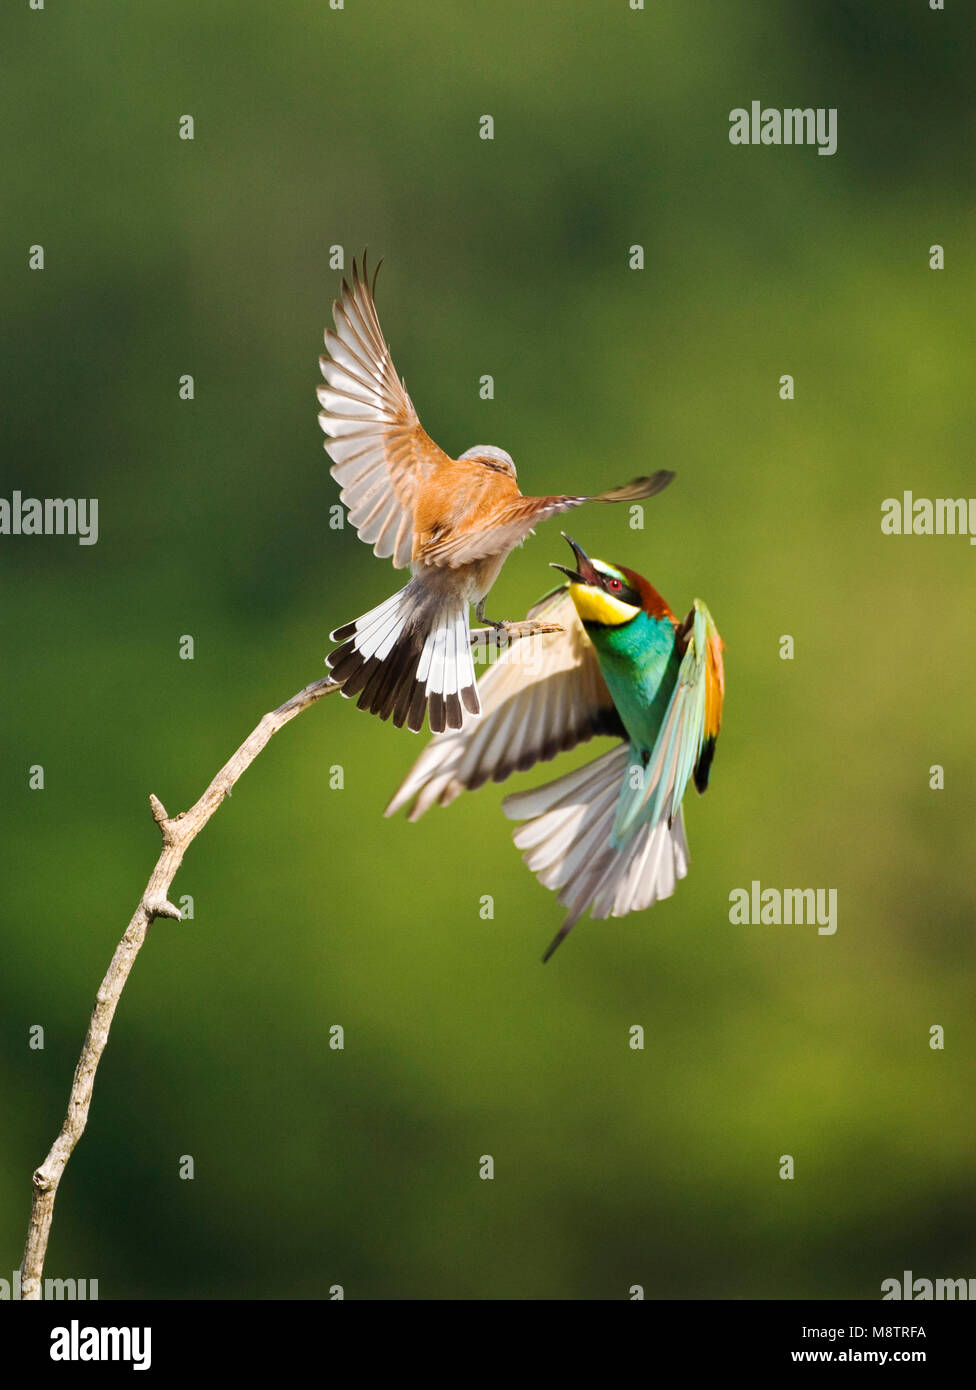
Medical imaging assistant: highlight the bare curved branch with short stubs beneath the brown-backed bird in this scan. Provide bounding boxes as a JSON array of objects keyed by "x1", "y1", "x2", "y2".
[{"x1": 21, "y1": 623, "x2": 560, "y2": 1300}]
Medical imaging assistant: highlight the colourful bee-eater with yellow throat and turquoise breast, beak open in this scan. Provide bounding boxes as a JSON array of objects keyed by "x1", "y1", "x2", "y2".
[{"x1": 387, "y1": 537, "x2": 724, "y2": 960}]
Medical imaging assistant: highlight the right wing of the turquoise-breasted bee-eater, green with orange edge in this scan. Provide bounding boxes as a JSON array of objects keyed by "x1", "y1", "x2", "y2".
[{"x1": 612, "y1": 599, "x2": 726, "y2": 844}]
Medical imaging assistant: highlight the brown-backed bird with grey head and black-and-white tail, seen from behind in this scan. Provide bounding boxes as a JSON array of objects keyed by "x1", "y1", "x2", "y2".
[{"x1": 318, "y1": 259, "x2": 674, "y2": 733}]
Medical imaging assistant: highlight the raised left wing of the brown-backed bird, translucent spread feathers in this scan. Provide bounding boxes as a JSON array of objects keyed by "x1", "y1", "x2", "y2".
[{"x1": 318, "y1": 257, "x2": 450, "y2": 570}]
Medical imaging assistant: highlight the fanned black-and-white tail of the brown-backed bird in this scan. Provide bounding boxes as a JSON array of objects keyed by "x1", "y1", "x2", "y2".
[{"x1": 325, "y1": 581, "x2": 481, "y2": 734}]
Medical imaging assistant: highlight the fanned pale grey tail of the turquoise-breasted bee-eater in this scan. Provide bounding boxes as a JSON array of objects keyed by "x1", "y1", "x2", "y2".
[{"x1": 502, "y1": 744, "x2": 688, "y2": 960}]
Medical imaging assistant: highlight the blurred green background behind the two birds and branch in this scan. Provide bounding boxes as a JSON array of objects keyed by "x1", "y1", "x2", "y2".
[{"x1": 0, "y1": 0, "x2": 976, "y2": 1298}]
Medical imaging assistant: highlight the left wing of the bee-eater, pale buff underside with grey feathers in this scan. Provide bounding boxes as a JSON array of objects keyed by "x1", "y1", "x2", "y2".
[{"x1": 387, "y1": 585, "x2": 627, "y2": 820}]
